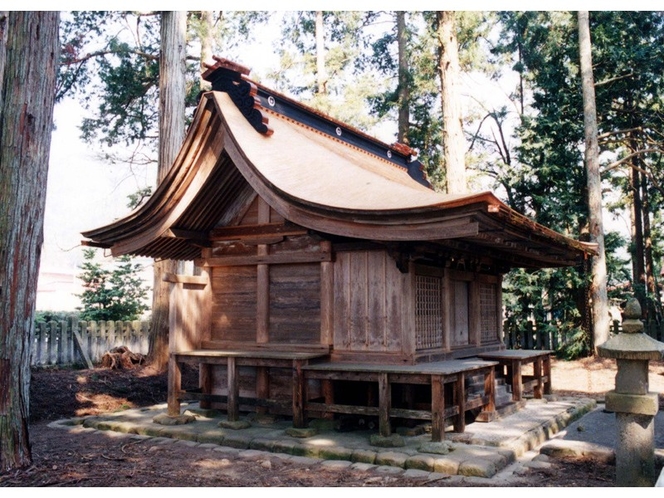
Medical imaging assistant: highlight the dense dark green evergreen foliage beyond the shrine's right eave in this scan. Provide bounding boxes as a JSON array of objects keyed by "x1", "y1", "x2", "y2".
[{"x1": 494, "y1": 12, "x2": 664, "y2": 356}]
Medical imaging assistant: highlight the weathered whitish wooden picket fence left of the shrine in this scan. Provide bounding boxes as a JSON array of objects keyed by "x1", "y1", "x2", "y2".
[{"x1": 31, "y1": 318, "x2": 149, "y2": 366}]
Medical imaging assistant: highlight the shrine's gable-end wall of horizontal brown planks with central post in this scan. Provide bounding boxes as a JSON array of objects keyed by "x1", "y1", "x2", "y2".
[{"x1": 210, "y1": 196, "x2": 326, "y2": 344}]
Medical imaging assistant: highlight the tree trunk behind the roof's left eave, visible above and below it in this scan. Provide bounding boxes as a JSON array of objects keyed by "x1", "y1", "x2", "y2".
[{"x1": 148, "y1": 12, "x2": 187, "y2": 371}]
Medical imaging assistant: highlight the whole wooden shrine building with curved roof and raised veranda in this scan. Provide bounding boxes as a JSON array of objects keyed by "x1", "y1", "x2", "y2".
[{"x1": 83, "y1": 59, "x2": 594, "y2": 440}]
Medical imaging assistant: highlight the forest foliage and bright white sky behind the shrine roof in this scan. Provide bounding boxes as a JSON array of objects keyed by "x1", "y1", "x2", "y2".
[{"x1": 38, "y1": 5, "x2": 664, "y2": 356}]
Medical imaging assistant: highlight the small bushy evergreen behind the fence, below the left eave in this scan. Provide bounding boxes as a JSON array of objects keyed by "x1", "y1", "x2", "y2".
[{"x1": 77, "y1": 249, "x2": 149, "y2": 321}]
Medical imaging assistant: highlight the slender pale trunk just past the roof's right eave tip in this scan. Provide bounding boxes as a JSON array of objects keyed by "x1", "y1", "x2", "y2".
[{"x1": 578, "y1": 11, "x2": 610, "y2": 348}]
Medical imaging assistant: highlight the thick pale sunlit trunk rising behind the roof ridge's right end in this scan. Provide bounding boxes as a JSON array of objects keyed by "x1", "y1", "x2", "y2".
[{"x1": 436, "y1": 12, "x2": 466, "y2": 194}]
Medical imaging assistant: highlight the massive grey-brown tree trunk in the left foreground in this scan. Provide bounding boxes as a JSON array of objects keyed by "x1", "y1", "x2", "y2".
[{"x1": 0, "y1": 11, "x2": 59, "y2": 473}]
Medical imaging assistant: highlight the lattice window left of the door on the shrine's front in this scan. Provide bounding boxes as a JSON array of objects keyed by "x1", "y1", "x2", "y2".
[{"x1": 415, "y1": 275, "x2": 443, "y2": 349}]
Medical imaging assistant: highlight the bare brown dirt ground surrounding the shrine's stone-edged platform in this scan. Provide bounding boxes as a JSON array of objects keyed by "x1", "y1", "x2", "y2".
[{"x1": 0, "y1": 358, "x2": 664, "y2": 487}]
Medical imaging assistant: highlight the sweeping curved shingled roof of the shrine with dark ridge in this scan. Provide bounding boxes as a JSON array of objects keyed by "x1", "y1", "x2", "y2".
[{"x1": 83, "y1": 60, "x2": 594, "y2": 267}]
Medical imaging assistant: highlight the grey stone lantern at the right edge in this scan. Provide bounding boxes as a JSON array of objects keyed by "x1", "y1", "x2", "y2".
[{"x1": 597, "y1": 298, "x2": 664, "y2": 486}]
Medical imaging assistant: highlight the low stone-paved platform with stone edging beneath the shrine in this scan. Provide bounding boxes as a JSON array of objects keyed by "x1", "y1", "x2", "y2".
[{"x1": 51, "y1": 397, "x2": 596, "y2": 479}]
